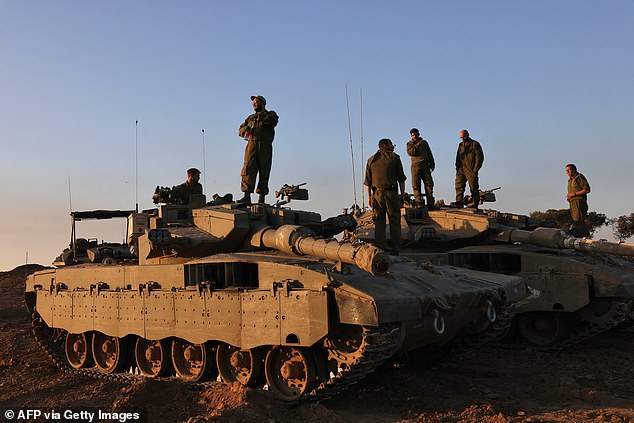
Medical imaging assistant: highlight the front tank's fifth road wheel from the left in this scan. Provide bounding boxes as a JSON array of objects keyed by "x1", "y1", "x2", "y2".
[{"x1": 216, "y1": 343, "x2": 262, "y2": 386}]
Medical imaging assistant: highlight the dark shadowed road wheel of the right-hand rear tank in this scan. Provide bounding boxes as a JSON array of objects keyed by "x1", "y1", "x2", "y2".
[{"x1": 517, "y1": 311, "x2": 569, "y2": 347}]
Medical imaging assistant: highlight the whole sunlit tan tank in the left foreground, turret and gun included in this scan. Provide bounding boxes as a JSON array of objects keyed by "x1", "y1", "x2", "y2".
[{"x1": 25, "y1": 185, "x2": 529, "y2": 401}]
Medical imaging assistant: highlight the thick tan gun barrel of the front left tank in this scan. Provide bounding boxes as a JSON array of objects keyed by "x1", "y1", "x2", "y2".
[{"x1": 251, "y1": 225, "x2": 390, "y2": 275}]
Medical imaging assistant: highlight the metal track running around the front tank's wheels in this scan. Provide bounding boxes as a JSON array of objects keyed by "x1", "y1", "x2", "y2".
[{"x1": 31, "y1": 311, "x2": 400, "y2": 401}]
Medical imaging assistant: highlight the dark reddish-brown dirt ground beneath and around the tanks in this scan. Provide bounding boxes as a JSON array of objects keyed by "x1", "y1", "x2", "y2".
[{"x1": 0, "y1": 265, "x2": 634, "y2": 423}]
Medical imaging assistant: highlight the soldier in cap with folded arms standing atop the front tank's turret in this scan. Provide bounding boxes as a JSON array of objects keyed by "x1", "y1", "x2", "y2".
[{"x1": 238, "y1": 95, "x2": 279, "y2": 203}]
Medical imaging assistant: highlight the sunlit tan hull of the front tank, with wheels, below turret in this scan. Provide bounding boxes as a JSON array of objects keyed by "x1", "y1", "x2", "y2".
[{"x1": 26, "y1": 248, "x2": 527, "y2": 399}]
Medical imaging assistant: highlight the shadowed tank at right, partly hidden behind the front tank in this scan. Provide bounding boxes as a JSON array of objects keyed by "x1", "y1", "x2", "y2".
[{"x1": 350, "y1": 190, "x2": 634, "y2": 349}]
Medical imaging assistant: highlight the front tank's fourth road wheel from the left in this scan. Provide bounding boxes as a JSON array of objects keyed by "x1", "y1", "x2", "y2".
[{"x1": 172, "y1": 338, "x2": 215, "y2": 382}]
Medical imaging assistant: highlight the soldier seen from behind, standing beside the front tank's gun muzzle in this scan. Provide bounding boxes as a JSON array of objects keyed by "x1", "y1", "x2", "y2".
[{"x1": 363, "y1": 138, "x2": 407, "y2": 255}]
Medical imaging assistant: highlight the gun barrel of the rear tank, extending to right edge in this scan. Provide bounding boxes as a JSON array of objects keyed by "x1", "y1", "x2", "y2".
[{"x1": 496, "y1": 227, "x2": 634, "y2": 257}]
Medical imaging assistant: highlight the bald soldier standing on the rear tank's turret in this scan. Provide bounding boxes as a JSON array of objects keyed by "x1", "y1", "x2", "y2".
[{"x1": 450, "y1": 129, "x2": 484, "y2": 209}]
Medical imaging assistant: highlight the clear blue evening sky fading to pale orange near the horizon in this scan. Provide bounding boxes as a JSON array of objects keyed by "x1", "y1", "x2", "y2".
[{"x1": 0, "y1": 0, "x2": 634, "y2": 271}]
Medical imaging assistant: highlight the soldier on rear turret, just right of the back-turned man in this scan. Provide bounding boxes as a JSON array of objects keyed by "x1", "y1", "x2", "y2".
[{"x1": 407, "y1": 128, "x2": 436, "y2": 210}]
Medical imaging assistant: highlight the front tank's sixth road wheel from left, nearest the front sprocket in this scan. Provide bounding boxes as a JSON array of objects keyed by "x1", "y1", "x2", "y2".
[{"x1": 264, "y1": 346, "x2": 317, "y2": 401}]
